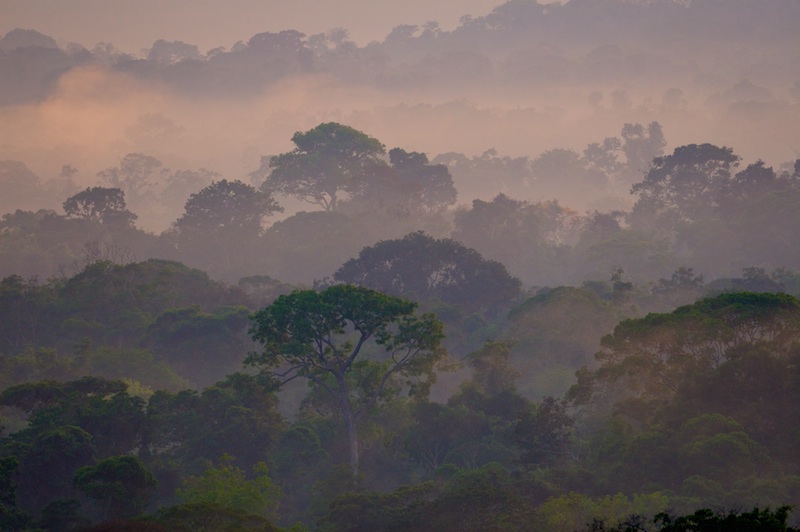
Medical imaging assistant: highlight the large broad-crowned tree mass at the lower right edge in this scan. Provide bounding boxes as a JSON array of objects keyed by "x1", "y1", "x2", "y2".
[{"x1": 570, "y1": 293, "x2": 800, "y2": 510}]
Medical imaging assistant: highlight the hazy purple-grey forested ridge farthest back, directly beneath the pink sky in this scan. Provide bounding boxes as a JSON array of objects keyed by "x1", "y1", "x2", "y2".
[{"x1": 0, "y1": 0, "x2": 796, "y2": 105}]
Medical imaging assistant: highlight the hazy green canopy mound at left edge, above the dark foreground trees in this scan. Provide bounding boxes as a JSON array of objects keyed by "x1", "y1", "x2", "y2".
[{"x1": 0, "y1": 260, "x2": 248, "y2": 390}]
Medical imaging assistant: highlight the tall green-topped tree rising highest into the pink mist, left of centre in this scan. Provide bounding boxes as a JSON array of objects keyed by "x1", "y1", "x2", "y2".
[{"x1": 253, "y1": 122, "x2": 388, "y2": 211}]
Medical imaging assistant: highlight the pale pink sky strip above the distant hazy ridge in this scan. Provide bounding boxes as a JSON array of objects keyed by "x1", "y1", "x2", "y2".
[{"x1": 0, "y1": 0, "x2": 520, "y2": 54}]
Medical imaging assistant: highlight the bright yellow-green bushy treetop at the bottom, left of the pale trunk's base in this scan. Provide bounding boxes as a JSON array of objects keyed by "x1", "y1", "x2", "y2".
[{"x1": 178, "y1": 455, "x2": 281, "y2": 519}]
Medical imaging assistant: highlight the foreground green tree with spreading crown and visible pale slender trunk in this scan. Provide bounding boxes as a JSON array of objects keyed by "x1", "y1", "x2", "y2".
[{"x1": 245, "y1": 285, "x2": 445, "y2": 473}]
